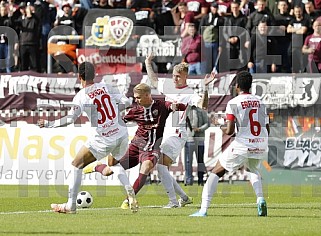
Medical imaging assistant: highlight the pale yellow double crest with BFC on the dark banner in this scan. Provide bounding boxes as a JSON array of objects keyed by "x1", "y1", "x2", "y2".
[{"x1": 86, "y1": 16, "x2": 133, "y2": 47}]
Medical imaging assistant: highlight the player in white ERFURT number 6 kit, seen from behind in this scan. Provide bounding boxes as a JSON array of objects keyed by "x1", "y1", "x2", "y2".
[{"x1": 190, "y1": 71, "x2": 270, "y2": 217}]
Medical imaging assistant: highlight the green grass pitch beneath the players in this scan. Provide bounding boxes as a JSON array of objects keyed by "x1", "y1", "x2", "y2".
[{"x1": 0, "y1": 182, "x2": 321, "y2": 236}]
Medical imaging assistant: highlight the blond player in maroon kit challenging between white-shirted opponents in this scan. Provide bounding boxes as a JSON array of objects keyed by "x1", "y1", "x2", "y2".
[{"x1": 84, "y1": 83, "x2": 189, "y2": 209}]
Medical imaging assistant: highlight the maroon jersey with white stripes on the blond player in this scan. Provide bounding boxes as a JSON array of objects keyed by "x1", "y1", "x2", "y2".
[{"x1": 124, "y1": 100, "x2": 172, "y2": 151}]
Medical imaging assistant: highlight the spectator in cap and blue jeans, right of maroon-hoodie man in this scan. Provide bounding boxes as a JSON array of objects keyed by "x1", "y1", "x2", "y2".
[{"x1": 199, "y1": 2, "x2": 224, "y2": 73}]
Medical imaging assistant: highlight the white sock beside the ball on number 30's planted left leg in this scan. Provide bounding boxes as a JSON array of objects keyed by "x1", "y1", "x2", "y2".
[{"x1": 67, "y1": 167, "x2": 82, "y2": 210}]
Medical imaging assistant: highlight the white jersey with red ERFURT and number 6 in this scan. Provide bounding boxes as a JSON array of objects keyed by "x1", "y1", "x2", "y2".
[{"x1": 226, "y1": 93, "x2": 269, "y2": 158}]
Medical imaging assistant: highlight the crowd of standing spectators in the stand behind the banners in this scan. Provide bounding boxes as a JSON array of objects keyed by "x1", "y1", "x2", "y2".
[{"x1": 0, "y1": 0, "x2": 321, "y2": 74}]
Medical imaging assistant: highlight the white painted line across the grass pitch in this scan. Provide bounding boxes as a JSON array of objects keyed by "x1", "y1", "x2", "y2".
[{"x1": 0, "y1": 203, "x2": 256, "y2": 215}]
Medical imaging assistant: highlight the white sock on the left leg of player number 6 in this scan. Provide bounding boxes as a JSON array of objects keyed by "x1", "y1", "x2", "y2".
[{"x1": 200, "y1": 173, "x2": 220, "y2": 213}]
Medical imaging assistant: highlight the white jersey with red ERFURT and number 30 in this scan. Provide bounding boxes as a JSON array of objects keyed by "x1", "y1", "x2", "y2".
[{"x1": 73, "y1": 83, "x2": 128, "y2": 139}]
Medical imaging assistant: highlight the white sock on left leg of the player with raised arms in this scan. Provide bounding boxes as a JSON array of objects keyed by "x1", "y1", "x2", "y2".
[{"x1": 156, "y1": 164, "x2": 178, "y2": 204}]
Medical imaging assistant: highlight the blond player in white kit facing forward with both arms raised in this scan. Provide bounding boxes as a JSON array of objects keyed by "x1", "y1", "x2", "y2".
[{"x1": 145, "y1": 53, "x2": 214, "y2": 208}]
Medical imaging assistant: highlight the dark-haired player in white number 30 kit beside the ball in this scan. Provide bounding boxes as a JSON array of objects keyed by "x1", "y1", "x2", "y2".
[{"x1": 38, "y1": 62, "x2": 137, "y2": 213}]
